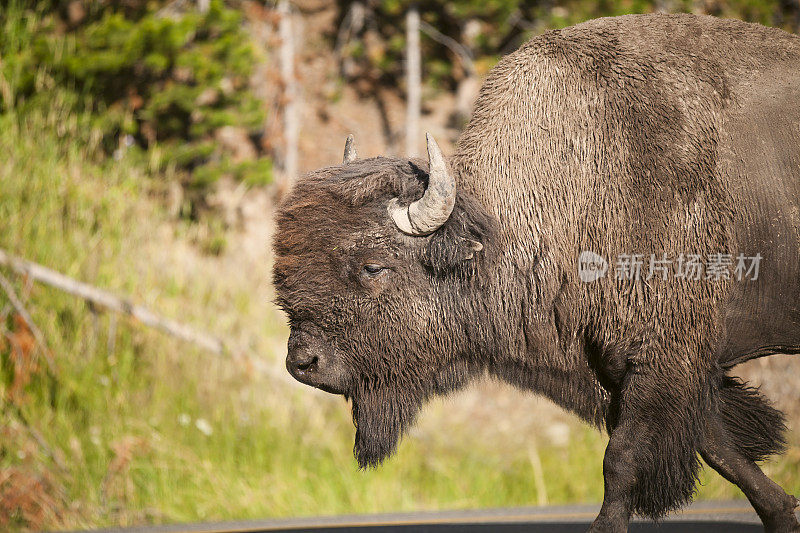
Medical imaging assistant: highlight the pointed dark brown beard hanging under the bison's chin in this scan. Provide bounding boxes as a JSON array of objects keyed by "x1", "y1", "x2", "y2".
[{"x1": 351, "y1": 385, "x2": 422, "y2": 468}]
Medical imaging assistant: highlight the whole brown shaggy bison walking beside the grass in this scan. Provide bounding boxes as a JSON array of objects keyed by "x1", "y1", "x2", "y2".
[{"x1": 273, "y1": 14, "x2": 800, "y2": 531}]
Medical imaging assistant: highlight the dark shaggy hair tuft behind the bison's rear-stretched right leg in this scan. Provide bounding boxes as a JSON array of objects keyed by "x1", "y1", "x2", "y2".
[{"x1": 717, "y1": 376, "x2": 786, "y2": 461}]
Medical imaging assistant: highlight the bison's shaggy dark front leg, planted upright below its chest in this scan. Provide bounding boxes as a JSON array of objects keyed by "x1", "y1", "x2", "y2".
[{"x1": 589, "y1": 365, "x2": 703, "y2": 532}]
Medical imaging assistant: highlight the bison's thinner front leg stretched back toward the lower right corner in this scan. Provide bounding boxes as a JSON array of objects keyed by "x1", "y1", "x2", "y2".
[{"x1": 701, "y1": 420, "x2": 800, "y2": 533}]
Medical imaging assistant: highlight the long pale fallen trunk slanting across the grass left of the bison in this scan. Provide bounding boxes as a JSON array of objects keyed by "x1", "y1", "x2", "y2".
[{"x1": 0, "y1": 250, "x2": 227, "y2": 356}]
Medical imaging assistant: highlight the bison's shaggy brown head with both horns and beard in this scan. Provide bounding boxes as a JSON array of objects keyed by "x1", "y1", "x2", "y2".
[{"x1": 273, "y1": 135, "x2": 494, "y2": 467}]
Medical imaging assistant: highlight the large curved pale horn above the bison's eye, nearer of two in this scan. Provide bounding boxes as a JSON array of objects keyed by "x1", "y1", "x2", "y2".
[{"x1": 389, "y1": 133, "x2": 456, "y2": 235}]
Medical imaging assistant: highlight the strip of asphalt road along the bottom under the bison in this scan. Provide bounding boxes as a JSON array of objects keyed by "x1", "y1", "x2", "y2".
[{"x1": 84, "y1": 500, "x2": 796, "y2": 533}]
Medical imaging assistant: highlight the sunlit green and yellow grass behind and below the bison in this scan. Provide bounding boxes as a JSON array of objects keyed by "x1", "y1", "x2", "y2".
[{"x1": 0, "y1": 93, "x2": 800, "y2": 528}]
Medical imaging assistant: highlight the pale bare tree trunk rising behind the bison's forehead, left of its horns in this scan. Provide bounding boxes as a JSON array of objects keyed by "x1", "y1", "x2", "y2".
[{"x1": 278, "y1": 0, "x2": 300, "y2": 187}]
